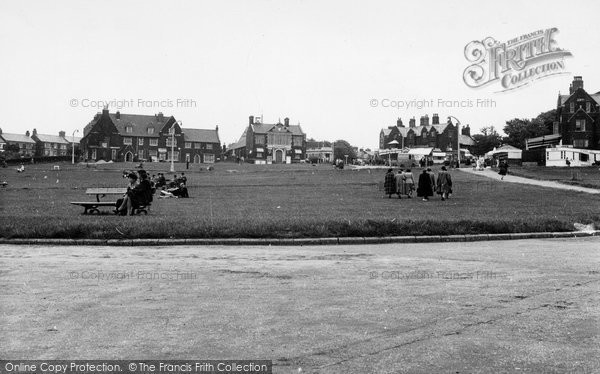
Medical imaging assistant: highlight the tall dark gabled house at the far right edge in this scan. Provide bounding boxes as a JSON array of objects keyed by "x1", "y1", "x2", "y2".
[{"x1": 553, "y1": 76, "x2": 600, "y2": 149}]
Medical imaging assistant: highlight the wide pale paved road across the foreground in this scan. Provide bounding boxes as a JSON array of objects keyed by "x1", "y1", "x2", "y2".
[{"x1": 0, "y1": 238, "x2": 600, "y2": 373}]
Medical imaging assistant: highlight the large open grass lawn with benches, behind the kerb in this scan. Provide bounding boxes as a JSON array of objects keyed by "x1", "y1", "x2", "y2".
[{"x1": 0, "y1": 163, "x2": 600, "y2": 238}]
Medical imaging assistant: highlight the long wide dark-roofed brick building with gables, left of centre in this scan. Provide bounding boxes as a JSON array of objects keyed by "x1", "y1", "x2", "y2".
[{"x1": 81, "y1": 108, "x2": 221, "y2": 162}]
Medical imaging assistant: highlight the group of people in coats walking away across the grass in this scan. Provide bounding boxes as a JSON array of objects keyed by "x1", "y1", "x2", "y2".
[{"x1": 383, "y1": 166, "x2": 452, "y2": 201}]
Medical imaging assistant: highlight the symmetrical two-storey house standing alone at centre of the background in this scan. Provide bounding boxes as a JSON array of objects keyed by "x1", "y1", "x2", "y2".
[{"x1": 240, "y1": 116, "x2": 306, "y2": 164}]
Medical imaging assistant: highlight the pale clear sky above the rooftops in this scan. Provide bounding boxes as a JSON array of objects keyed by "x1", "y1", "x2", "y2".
[{"x1": 0, "y1": 0, "x2": 600, "y2": 149}]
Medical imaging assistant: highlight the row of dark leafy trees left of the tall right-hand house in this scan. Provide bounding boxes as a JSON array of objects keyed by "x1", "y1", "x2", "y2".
[{"x1": 471, "y1": 109, "x2": 556, "y2": 155}]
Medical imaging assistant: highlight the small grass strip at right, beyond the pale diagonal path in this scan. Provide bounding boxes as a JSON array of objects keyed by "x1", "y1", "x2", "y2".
[{"x1": 509, "y1": 166, "x2": 600, "y2": 189}]
